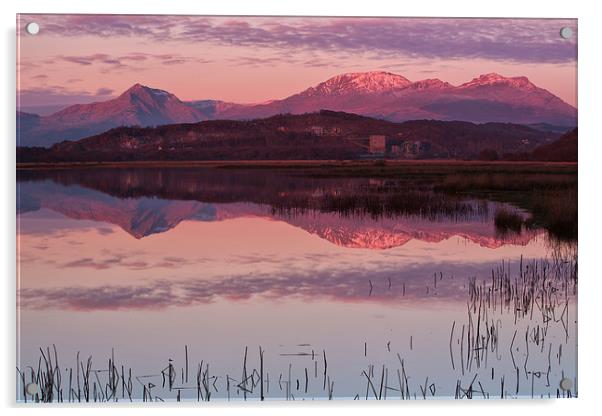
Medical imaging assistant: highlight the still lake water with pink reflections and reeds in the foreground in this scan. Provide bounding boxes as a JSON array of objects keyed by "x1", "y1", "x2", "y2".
[{"x1": 17, "y1": 168, "x2": 577, "y2": 401}]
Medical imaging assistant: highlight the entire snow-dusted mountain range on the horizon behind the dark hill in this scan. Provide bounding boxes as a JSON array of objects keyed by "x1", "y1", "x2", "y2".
[{"x1": 17, "y1": 71, "x2": 577, "y2": 146}]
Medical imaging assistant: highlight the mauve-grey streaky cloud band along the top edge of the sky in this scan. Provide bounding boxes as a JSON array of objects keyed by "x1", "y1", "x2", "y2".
[{"x1": 17, "y1": 15, "x2": 577, "y2": 63}]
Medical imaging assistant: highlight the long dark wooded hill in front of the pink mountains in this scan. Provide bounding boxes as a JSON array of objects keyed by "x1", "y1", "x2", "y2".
[{"x1": 17, "y1": 110, "x2": 557, "y2": 162}]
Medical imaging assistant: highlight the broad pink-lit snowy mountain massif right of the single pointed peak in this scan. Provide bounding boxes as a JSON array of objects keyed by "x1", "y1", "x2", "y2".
[{"x1": 216, "y1": 72, "x2": 577, "y2": 126}]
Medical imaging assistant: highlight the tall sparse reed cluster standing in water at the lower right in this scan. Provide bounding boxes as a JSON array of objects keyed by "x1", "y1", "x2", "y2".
[{"x1": 449, "y1": 253, "x2": 577, "y2": 398}]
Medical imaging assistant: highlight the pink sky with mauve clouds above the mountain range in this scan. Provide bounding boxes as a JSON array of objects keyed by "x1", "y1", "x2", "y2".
[{"x1": 17, "y1": 15, "x2": 577, "y2": 112}]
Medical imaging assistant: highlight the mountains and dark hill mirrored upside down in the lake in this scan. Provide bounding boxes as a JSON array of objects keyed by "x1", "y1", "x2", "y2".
[{"x1": 18, "y1": 170, "x2": 537, "y2": 249}]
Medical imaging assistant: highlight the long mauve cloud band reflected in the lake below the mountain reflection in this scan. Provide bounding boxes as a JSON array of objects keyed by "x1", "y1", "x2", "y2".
[{"x1": 19, "y1": 259, "x2": 516, "y2": 310}]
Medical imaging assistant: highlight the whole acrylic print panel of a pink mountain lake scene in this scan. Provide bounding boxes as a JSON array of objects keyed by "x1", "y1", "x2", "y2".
[{"x1": 16, "y1": 15, "x2": 577, "y2": 403}]
